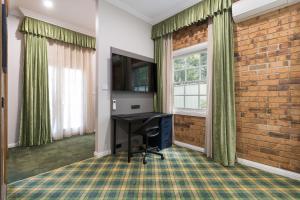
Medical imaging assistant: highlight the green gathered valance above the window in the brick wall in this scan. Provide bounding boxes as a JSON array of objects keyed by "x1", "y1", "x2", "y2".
[{"x1": 152, "y1": 0, "x2": 232, "y2": 39}]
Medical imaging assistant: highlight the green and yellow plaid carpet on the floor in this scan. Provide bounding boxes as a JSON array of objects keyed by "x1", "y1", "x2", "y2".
[{"x1": 8, "y1": 147, "x2": 300, "y2": 200}]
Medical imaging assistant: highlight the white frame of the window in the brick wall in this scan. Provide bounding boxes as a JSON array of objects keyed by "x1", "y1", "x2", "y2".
[{"x1": 172, "y1": 42, "x2": 209, "y2": 117}]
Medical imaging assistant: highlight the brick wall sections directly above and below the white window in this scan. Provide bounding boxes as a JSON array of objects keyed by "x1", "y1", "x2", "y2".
[{"x1": 173, "y1": 22, "x2": 207, "y2": 147}]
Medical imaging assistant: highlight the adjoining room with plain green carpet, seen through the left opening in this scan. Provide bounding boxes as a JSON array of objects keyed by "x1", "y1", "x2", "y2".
[{"x1": 3, "y1": 0, "x2": 96, "y2": 183}]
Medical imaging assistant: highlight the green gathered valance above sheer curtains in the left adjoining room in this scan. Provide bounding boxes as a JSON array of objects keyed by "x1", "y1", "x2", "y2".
[{"x1": 20, "y1": 17, "x2": 96, "y2": 49}]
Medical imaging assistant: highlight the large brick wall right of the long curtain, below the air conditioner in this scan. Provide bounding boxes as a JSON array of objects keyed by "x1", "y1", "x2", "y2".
[{"x1": 235, "y1": 4, "x2": 300, "y2": 172}]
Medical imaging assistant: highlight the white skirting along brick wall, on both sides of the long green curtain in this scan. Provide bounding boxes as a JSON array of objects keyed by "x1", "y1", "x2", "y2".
[{"x1": 174, "y1": 141, "x2": 300, "y2": 180}]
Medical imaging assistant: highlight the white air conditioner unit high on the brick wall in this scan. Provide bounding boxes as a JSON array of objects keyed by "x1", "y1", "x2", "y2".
[{"x1": 232, "y1": 0, "x2": 300, "y2": 23}]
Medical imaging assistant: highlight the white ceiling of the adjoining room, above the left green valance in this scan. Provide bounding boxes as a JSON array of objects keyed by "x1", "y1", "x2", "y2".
[{"x1": 10, "y1": 0, "x2": 96, "y2": 32}]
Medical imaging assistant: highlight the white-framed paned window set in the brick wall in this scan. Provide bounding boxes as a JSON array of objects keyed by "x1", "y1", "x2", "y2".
[{"x1": 173, "y1": 44, "x2": 207, "y2": 115}]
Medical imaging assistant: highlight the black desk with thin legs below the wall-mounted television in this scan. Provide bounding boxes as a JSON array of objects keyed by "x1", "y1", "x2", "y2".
[{"x1": 111, "y1": 112, "x2": 172, "y2": 163}]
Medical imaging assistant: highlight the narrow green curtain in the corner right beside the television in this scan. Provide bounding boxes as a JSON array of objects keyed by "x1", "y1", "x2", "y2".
[{"x1": 154, "y1": 37, "x2": 164, "y2": 112}]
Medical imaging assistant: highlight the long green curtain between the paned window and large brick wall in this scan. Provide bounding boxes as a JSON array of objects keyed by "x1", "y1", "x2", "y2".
[{"x1": 212, "y1": 11, "x2": 236, "y2": 166}]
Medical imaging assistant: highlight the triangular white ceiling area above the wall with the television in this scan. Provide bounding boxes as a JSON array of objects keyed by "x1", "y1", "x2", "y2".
[{"x1": 106, "y1": 0, "x2": 202, "y2": 25}]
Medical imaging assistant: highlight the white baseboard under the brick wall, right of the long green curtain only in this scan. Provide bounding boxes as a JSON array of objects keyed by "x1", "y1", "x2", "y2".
[{"x1": 238, "y1": 158, "x2": 300, "y2": 180}]
